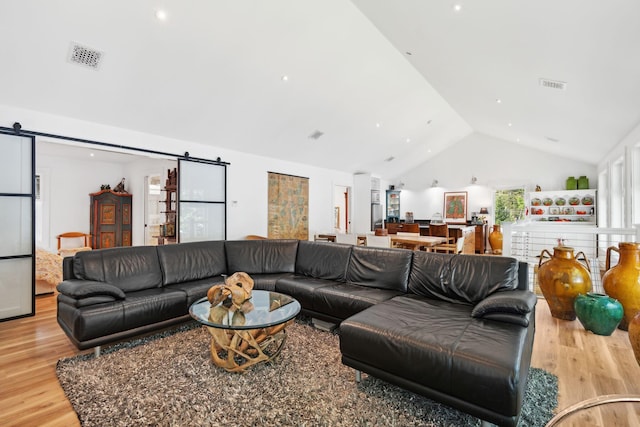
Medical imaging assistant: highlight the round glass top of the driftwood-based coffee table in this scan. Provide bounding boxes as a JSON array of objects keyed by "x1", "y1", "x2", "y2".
[{"x1": 189, "y1": 290, "x2": 300, "y2": 329}]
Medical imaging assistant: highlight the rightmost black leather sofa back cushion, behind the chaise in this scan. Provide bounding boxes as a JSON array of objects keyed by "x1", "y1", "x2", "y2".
[{"x1": 409, "y1": 251, "x2": 518, "y2": 305}]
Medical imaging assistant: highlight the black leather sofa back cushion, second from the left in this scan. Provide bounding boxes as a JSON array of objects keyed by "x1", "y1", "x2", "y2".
[{"x1": 157, "y1": 241, "x2": 227, "y2": 285}]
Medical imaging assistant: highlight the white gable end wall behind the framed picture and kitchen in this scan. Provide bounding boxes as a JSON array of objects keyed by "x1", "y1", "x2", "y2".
[{"x1": 399, "y1": 133, "x2": 598, "y2": 219}]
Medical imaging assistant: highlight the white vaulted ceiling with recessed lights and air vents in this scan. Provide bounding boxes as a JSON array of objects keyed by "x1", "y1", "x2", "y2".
[{"x1": 0, "y1": 0, "x2": 640, "y2": 179}]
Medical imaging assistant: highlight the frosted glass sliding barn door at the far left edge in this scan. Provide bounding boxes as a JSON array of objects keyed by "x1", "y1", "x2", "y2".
[{"x1": 0, "y1": 132, "x2": 35, "y2": 320}]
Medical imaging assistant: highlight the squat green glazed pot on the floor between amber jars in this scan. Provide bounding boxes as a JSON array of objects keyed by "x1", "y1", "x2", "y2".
[{"x1": 573, "y1": 292, "x2": 624, "y2": 336}]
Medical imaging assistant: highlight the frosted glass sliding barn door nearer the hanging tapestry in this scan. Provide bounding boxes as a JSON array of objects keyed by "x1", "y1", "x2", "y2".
[{"x1": 178, "y1": 159, "x2": 227, "y2": 243}]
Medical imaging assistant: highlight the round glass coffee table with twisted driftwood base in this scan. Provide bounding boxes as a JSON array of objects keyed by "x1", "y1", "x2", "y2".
[{"x1": 189, "y1": 290, "x2": 300, "y2": 372}]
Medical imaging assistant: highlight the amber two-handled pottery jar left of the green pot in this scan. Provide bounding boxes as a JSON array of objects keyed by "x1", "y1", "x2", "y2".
[{"x1": 538, "y1": 246, "x2": 591, "y2": 320}]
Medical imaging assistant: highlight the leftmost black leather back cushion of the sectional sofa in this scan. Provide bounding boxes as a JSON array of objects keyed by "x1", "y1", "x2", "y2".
[{"x1": 73, "y1": 246, "x2": 162, "y2": 292}]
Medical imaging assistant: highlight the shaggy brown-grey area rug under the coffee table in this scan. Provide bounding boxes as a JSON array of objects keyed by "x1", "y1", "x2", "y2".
[{"x1": 56, "y1": 322, "x2": 558, "y2": 427}]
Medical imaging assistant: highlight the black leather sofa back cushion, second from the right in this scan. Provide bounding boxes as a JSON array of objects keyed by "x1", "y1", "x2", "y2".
[{"x1": 347, "y1": 246, "x2": 413, "y2": 292}]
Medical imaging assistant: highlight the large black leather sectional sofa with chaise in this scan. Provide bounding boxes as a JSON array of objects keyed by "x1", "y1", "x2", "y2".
[{"x1": 57, "y1": 240, "x2": 536, "y2": 426}]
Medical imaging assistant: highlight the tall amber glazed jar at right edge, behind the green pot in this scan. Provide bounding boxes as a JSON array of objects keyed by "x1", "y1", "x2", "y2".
[{"x1": 602, "y1": 242, "x2": 640, "y2": 331}]
